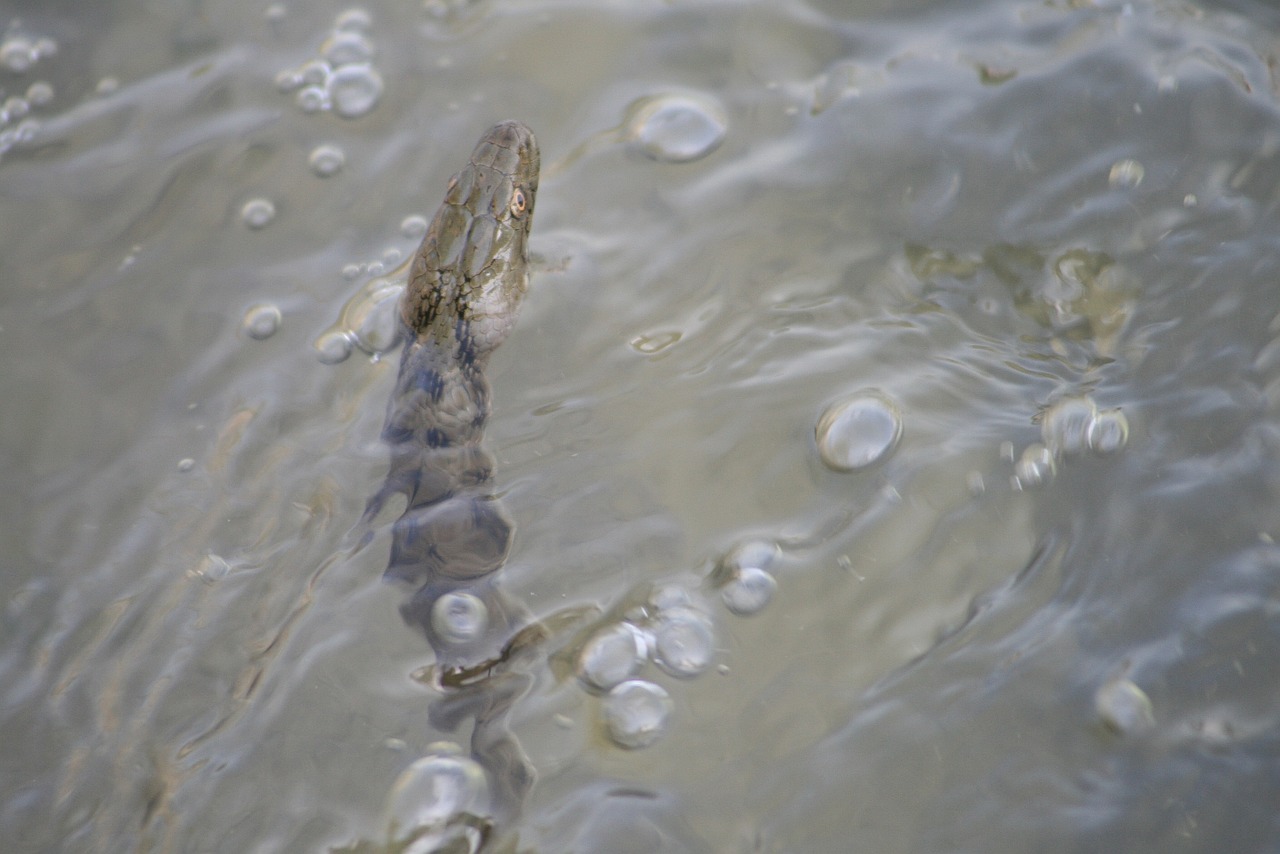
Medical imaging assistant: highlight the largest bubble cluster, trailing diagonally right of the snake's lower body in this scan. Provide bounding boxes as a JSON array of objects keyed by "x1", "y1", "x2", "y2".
[{"x1": 573, "y1": 540, "x2": 780, "y2": 749}]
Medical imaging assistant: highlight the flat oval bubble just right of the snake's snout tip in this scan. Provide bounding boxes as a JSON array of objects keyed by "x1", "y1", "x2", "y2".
[{"x1": 625, "y1": 95, "x2": 728, "y2": 163}]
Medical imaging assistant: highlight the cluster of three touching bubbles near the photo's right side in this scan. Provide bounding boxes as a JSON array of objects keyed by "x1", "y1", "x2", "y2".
[{"x1": 1014, "y1": 396, "x2": 1129, "y2": 489}]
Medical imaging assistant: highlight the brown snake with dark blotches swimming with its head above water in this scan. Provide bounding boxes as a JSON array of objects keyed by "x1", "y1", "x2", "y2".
[{"x1": 364, "y1": 122, "x2": 540, "y2": 829}]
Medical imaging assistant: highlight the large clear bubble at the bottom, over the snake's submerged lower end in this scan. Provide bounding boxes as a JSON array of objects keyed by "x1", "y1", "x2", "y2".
[{"x1": 387, "y1": 744, "x2": 489, "y2": 850}]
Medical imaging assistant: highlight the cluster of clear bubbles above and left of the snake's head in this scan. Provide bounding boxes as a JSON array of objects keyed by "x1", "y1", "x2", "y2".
[{"x1": 275, "y1": 9, "x2": 383, "y2": 120}]
